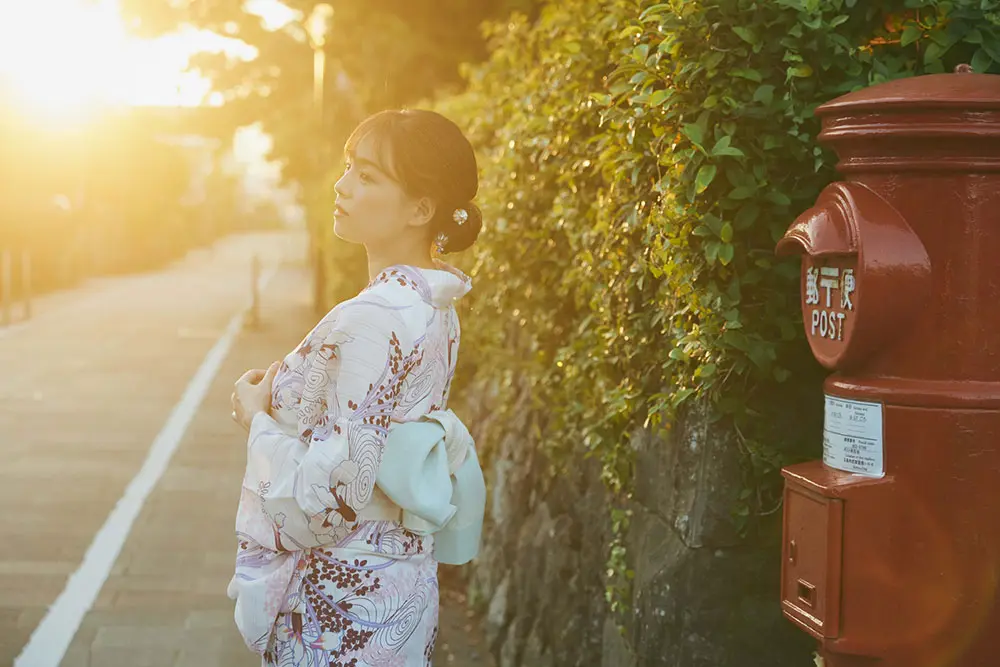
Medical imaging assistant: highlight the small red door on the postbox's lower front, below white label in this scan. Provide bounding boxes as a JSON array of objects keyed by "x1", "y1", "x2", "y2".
[{"x1": 781, "y1": 480, "x2": 843, "y2": 639}]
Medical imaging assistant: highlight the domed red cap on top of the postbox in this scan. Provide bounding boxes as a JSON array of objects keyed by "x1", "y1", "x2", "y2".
[{"x1": 816, "y1": 72, "x2": 1000, "y2": 117}]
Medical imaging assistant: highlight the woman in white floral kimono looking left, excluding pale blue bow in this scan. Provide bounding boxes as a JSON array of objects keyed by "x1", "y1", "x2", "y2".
[{"x1": 229, "y1": 110, "x2": 482, "y2": 667}]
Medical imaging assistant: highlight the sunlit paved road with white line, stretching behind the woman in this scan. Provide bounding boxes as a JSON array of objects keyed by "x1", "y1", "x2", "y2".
[{"x1": 0, "y1": 232, "x2": 489, "y2": 667}]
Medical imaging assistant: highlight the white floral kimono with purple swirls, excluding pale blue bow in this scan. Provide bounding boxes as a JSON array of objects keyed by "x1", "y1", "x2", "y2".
[{"x1": 229, "y1": 262, "x2": 471, "y2": 667}]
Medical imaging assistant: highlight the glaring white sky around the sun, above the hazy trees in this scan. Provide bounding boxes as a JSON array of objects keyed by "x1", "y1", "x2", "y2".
[{"x1": 0, "y1": 0, "x2": 295, "y2": 117}]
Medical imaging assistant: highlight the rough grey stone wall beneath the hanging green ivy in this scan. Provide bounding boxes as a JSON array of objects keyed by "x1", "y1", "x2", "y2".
[{"x1": 470, "y1": 397, "x2": 813, "y2": 667}]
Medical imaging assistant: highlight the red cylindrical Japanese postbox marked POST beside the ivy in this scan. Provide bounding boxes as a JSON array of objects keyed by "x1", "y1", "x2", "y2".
[{"x1": 777, "y1": 72, "x2": 1000, "y2": 667}]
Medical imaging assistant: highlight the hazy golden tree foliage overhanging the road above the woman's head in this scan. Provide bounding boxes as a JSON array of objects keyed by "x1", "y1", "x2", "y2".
[{"x1": 122, "y1": 0, "x2": 540, "y2": 181}]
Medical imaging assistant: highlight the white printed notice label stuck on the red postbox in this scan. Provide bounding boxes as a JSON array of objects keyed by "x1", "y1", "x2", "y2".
[{"x1": 823, "y1": 396, "x2": 885, "y2": 477}]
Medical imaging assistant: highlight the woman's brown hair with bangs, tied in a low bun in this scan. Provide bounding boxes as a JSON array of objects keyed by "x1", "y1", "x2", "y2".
[{"x1": 344, "y1": 109, "x2": 483, "y2": 252}]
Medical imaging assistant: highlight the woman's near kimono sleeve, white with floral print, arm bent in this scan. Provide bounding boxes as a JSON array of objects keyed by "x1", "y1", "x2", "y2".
[{"x1": 244, "y1": 302, "x2": 417, "y2": 550}]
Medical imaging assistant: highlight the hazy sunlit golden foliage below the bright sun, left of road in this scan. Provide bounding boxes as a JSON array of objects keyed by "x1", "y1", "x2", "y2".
[{"x1": 0, "y1": 90, "x2": 257, "y2": 298}]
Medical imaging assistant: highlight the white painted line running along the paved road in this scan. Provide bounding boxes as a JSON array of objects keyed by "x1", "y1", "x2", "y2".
[{"x1": 14, "y1": 269, "x2": 277, "y2": 667}]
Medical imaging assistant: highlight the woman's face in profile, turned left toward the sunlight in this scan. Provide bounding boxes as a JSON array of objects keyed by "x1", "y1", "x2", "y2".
[{"x1": 333, "y1": 135, "x2": 429, "y2": 248}]
